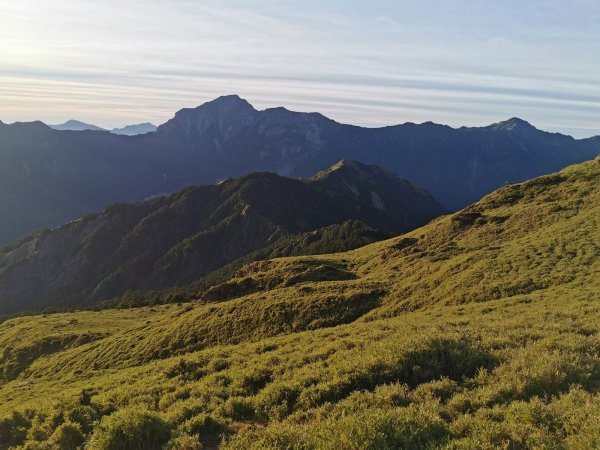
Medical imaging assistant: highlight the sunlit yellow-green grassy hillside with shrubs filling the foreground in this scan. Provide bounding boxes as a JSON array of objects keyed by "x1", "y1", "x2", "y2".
[{"x1": 0, "y1": 156, "x2": 600, "y2": 449}]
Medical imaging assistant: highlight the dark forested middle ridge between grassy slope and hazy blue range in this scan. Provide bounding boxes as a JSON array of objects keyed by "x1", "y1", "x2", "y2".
[{"x1": 0, "y1": 161, "x2": 445, "y2": 313}]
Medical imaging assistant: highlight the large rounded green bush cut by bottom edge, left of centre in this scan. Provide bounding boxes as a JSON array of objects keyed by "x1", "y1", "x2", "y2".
[{"x1": 89, "y1": 408, "x2": 170, "y2": 450}]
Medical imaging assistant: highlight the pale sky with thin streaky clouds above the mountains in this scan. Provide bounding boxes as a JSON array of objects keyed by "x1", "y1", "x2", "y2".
[{"x1": 0, "y1": 0, "x2": 600, "y2": 137}]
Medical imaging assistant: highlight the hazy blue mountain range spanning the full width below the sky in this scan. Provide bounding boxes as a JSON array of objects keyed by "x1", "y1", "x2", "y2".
[{"x1": 0, "y1": 92, "x2": 600, "y2": 244}]
